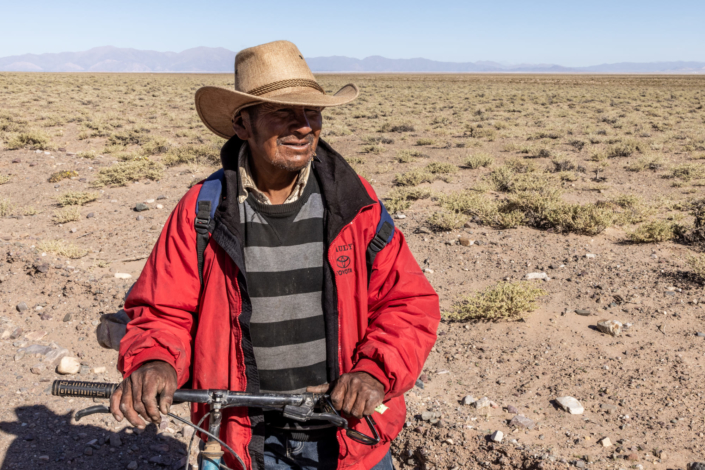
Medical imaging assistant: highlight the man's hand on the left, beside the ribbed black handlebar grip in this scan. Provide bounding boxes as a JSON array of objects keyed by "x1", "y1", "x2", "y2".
[{"x1": 110, "y1": 361, "x2": 178, "y2": 429}]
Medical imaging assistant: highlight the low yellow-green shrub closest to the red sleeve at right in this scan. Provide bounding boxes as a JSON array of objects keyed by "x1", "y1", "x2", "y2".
[{"x1": 447, "y1": 281, "x2": 547, "y2": 321}]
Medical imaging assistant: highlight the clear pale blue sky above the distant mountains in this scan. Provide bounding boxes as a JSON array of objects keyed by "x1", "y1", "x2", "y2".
[{"x1": 0, "y1": 0, "x2": 705, "y2": 66}]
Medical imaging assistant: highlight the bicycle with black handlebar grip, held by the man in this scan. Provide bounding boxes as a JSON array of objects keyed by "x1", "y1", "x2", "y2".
[{"x1": 51, "y1": 380, "x2": 379, "y2": 470}]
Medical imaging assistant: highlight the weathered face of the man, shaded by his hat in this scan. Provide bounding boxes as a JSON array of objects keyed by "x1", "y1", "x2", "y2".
[{"x1": 242, "y1": 104, "x2": 323, "y2": 172}]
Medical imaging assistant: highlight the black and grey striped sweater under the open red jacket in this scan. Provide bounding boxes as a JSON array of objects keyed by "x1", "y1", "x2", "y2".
[{"x1": 240, "y1": 176, "x2": 327, "y2": 393}]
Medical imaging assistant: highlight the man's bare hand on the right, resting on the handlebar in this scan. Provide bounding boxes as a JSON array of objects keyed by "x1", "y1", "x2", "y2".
[{"x1": 306, "y1": 372, "x2": 384, "y2": 419}]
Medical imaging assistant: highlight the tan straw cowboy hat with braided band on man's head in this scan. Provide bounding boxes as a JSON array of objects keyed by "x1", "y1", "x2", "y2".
[{"x1": 196, "y1": 41, "x2": 360, "y2": 139}]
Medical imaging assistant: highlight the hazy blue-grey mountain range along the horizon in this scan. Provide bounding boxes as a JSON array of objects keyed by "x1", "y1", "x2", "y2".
[{"x1": 0, "y1": 46, "x2": 705, "y2": 74}]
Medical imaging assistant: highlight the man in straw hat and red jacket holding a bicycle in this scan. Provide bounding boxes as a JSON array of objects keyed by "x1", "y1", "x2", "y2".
[{"x1": 111, "y1": 41, "x2": 440, "y2": 470}]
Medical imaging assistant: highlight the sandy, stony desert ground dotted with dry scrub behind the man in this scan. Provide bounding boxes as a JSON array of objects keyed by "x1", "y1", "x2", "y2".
[{"x1": 0, "y1": 73, "x2": 705, "y2": 470}]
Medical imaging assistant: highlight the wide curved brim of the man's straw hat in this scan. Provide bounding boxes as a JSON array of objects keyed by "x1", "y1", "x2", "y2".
[{"x1": 196, "y1": 83, "x2": 360, "y2": 139}]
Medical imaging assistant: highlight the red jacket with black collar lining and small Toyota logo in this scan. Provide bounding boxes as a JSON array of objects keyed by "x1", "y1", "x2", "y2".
[{"x1": 118, "y1": 137, "x2": 440, "y2": 470}]
